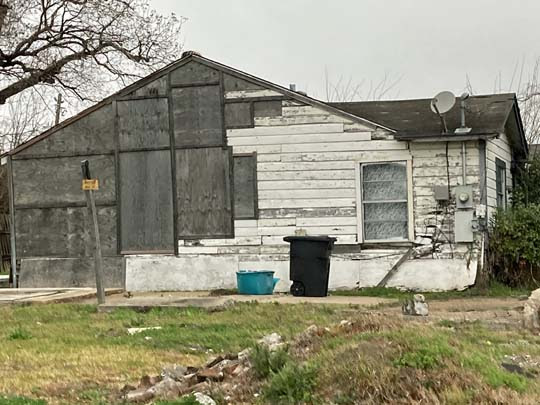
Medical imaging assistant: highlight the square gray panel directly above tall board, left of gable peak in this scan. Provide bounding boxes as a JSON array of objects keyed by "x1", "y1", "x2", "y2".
[{"x1": 118, "y1": 98, "x2": 170, "y2": 150}]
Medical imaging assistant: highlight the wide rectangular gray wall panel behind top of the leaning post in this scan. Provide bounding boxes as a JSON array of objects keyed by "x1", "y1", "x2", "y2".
[{"x1": 13, "y1": 156, "x2": 116, "y2": 206}]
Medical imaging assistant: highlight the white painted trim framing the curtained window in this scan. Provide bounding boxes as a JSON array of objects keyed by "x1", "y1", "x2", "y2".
[{"x1": 355, "y1": 153, "x2": 414, "y2": 243}]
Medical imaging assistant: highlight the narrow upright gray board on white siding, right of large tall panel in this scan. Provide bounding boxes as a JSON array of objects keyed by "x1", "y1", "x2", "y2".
[{"x1": 234, "y1": 154, "x2": 257, "y2": 219}]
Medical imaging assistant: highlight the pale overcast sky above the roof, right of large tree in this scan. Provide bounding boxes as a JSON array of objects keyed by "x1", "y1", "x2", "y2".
[{"x1": 153, "y1": 0, "x2": 540, "y2": 99}]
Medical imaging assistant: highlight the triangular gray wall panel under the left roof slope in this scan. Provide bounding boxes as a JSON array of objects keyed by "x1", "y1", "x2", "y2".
[{"x1": 15, "y1": 104, "x2": 114, "y2": 158}]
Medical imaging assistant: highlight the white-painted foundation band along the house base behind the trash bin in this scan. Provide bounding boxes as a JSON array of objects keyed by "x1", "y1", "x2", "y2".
[{"x1": 126, "y1": 254, "x2": 476, "y2": 292}]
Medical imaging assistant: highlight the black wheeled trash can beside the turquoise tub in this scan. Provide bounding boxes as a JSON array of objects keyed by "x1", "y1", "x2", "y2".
[{"x1": 283, "y1": 236, "x2": 336, "y2": 297}]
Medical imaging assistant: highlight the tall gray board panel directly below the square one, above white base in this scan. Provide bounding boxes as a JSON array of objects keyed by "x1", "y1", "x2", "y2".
[{"x1": 120, "y1": 150, "x2": 174, "y2": 252}]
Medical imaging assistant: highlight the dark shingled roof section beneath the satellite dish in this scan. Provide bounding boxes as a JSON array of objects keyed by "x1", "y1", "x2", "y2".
[{"x1": 330, "y1": 94, "x2": 515, "y2": 135}]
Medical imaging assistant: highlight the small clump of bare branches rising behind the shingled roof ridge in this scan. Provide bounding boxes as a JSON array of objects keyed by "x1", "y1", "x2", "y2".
[{"x1": 324, "y1": 68, "x2": 402, "y2": 103}]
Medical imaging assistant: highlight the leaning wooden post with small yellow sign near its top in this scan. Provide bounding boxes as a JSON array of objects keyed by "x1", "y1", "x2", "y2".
[{"x1": 81, "y1": 160, "x2": 105, "y2": 304}]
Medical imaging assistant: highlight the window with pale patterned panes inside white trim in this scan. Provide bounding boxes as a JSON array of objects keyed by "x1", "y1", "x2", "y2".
[{"x1": 361, "y1": 162, "x2": 408, "y2": 241}]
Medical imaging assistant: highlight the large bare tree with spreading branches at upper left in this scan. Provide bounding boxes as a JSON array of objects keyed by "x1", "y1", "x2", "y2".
[{"x1": 0, "y1": 0, "x2": 183, "y2": 104}]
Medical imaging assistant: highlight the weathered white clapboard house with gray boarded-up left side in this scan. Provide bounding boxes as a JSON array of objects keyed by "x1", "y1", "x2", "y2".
[{"x1": 2, "y1": 53, "x2": 527, "y2": 290}]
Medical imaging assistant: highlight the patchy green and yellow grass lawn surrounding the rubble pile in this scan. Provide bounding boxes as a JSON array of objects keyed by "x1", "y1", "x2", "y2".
[{"x1": 0, "y1": 303, "x2": 540, "y2": 405}]
